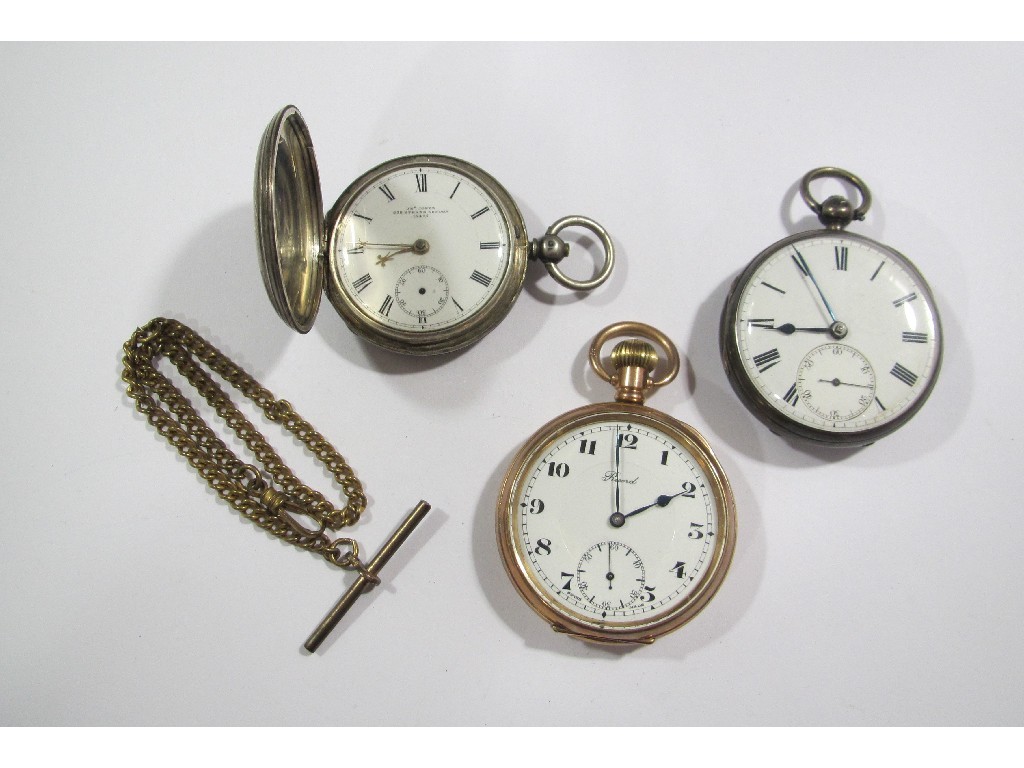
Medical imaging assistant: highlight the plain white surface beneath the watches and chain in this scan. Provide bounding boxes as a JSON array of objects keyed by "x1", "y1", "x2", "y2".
[{"x1": 0, "y1": 43, "x2": 1024, "y2": 725}]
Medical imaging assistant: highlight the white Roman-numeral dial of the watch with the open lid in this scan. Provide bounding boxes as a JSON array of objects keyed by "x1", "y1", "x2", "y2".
[{"x1": 330, "y1": 163, "x2": 513, "y2": 333}]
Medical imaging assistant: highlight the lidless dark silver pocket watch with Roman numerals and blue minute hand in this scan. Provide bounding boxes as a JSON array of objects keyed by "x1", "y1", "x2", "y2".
[{"x1": 720, "y1": 168, "x2": 942, "y2": 446}]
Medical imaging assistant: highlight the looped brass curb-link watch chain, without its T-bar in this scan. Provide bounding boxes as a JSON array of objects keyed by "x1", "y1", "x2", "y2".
[{"x1": 121, "y1": 317, "x2": 367, "y2": 572}]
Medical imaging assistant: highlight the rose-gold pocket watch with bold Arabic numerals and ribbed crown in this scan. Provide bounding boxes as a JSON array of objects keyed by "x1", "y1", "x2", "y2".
[{"x1": 497, "y1": 323, "x2": 736, "y2": 644}]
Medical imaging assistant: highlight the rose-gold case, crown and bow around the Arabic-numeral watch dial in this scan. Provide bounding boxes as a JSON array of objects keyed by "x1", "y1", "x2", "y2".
[{"x1": 496, "y1": 323, "x2": 736, "y2": 644}]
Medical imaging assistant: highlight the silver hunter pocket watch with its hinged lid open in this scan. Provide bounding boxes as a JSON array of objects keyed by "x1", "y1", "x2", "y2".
[{"x1": 254, "y1": 106, "x2": 614, "y2": 354}]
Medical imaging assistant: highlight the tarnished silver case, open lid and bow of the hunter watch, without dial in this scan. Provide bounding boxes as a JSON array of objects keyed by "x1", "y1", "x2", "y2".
[{"x1": 254, "y1": 105, "x2": 614, "y2": 354}]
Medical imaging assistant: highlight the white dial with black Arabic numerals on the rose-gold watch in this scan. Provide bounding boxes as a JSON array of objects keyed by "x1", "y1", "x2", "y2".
[{"x1": 505, "y1": 408, "x2": 734, "y2": 640}]
